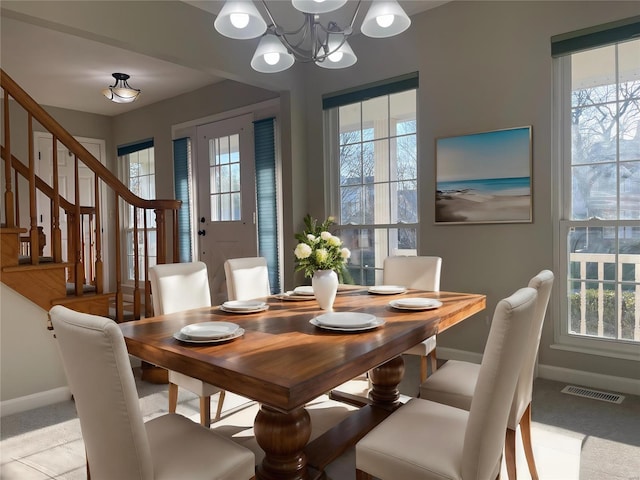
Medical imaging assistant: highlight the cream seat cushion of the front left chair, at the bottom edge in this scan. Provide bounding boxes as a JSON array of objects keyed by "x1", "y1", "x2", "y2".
[{"x1": 146, "y1": 413, "x2": 255, "y2": 480}]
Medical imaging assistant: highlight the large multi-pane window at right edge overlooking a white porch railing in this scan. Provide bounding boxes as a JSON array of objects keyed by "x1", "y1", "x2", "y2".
[{"x1": 556, "y1": 35, "x2": 640, "y2": 350}]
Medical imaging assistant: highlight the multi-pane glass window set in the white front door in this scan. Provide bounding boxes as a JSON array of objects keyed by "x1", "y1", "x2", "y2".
[{"x1": 209, "y1": 133, "x2": 242, "y2": 222}]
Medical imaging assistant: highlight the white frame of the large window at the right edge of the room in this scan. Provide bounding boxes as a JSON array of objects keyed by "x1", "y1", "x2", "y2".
[{"x1": 551, "y1": 45, "x2": 640, "y2": 361}]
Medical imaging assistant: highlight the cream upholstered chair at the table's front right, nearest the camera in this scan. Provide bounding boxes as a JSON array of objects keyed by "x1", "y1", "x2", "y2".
[{"x1": 356, "y1": 287, "x2": 537, "y2": 480}]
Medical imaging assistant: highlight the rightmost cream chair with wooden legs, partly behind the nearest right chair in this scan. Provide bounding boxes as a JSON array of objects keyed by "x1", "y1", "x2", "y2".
[{"x1": 420, "y1": 270, "x2": 554, "y2": 480}]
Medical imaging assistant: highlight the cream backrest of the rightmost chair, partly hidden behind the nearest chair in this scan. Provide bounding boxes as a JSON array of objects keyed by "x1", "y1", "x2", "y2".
[{"x1": 507, "y1": 270, "x2": 553, "y2": 430}]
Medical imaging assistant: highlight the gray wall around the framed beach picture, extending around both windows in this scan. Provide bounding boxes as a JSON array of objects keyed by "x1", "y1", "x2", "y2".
[{"x1": 306, "y1": 1, "x2": 640, "y2": 379}]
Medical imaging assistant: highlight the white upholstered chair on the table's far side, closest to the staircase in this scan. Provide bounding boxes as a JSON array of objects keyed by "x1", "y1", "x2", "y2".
[{"x1": 149, "y1": 262, "x2": 225, "y2": 427}]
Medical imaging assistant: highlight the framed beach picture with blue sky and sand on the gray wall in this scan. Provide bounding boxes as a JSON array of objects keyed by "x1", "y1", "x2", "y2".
[{"x1": 435, "y1": 126, "x2": 533, "y2": 224}]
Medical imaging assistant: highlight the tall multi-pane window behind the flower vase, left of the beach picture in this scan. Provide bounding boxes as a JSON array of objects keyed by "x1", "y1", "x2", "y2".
[{"x1": 325, "y1": 82, "x2": 419, "y2": 285}]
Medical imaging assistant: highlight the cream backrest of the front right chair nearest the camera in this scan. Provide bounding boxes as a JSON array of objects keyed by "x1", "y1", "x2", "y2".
[{"x1": 462, "y1": 287, "x2": 537, "y2": 478}]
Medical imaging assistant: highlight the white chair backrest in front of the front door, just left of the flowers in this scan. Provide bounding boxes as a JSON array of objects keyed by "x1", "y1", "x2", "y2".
[{"x1": 224, "y1": 257, "x2": 271, "y2": 300}]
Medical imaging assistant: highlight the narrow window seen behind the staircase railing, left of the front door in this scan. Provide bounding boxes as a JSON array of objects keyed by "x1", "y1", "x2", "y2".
[{"x1": 120, "y1": 146, "x2": 157, "y2": 280}]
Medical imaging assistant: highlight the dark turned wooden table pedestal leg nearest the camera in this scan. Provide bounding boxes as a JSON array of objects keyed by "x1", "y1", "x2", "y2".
[{"x1": 254, "y1": 405, "x2": 311, "y2": 480}]
